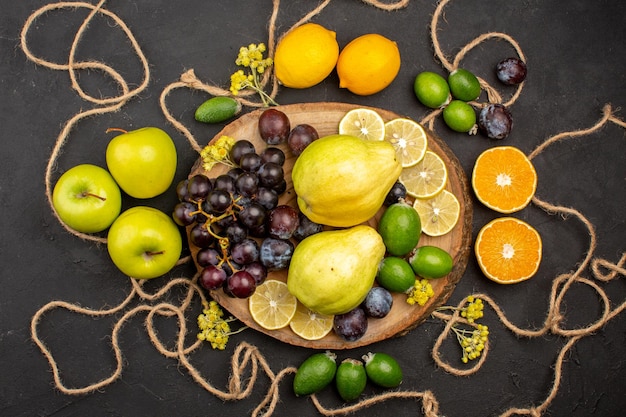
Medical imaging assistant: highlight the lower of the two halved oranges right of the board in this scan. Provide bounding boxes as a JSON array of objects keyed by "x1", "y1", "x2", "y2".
[{"x1": 474, "y1": 217, "x2": 542, "y2": 284}]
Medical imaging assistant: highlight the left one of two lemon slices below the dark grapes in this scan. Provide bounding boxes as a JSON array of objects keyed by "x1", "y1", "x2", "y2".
[{"x1": 248, "y1": 280, "x2": 298, "y2": 330}]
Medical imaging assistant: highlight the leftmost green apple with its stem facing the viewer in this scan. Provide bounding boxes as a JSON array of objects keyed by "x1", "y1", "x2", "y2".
[{"x1": 52, "y1": 164, "x2": 122, "y2": 233}]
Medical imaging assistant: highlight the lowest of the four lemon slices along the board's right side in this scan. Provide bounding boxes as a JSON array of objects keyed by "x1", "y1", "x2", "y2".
[{"x1": 413, "y1": 190, "x2": 461, "y2": 236}]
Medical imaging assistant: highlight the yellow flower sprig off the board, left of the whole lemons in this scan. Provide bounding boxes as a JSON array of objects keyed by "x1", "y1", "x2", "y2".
[{"x1": 230, "y1": 43, "x2": 278, "y2": 107}]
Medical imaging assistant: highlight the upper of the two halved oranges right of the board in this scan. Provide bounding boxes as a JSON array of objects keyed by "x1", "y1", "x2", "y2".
[{"x1": 472, "y1": 146, "x2": 537, "y2": 213}]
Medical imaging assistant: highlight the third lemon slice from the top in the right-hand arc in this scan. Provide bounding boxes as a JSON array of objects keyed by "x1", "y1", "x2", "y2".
[{"x1": 398, "y1": 151, "x2": 448, "y2": 198}]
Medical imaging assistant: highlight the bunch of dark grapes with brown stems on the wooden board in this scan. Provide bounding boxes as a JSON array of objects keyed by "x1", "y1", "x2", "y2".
[{"x1": 172, "y1": 140, "x2": 311, "y2": 298}]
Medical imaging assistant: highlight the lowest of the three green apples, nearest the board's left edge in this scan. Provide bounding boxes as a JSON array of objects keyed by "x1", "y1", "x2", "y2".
[{"x1": 107, "y1": 206, "x2": 183, "y2": 279}]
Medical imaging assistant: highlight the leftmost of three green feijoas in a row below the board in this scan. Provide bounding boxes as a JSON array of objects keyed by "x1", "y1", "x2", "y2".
[{"x1": 293, "y1": 351, "x2": 337, "y2": 396}]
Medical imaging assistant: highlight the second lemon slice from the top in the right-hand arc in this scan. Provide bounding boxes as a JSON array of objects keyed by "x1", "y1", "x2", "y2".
[{"x1": 385, "y1": 119, "x2": 428, "y2": 168}]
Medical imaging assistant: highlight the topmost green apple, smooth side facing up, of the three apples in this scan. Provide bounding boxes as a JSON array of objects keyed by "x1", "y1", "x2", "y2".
[{"x1": 106, "y1": 127, "x2": 177, "y2": 198}]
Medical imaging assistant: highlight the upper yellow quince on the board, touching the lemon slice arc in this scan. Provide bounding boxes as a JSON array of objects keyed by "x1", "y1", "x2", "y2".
[{"x1": 291, "y1": 135, "x2": 402, "y2": 227}]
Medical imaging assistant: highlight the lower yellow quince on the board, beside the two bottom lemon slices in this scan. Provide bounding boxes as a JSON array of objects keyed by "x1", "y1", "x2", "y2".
[{"x1": 287, "y1": 225, "x2": 385, "y2": 315}]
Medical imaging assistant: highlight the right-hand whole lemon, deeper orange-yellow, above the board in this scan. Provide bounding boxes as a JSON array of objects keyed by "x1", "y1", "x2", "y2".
[{"x1": 337, "y1": 33, "x2": 400, "y2": 96}]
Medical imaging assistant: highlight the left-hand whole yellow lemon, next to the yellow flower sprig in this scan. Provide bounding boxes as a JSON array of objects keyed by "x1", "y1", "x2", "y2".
[{"x1": 274, "y1": 23, "x2": 339, "y2": 88}]
